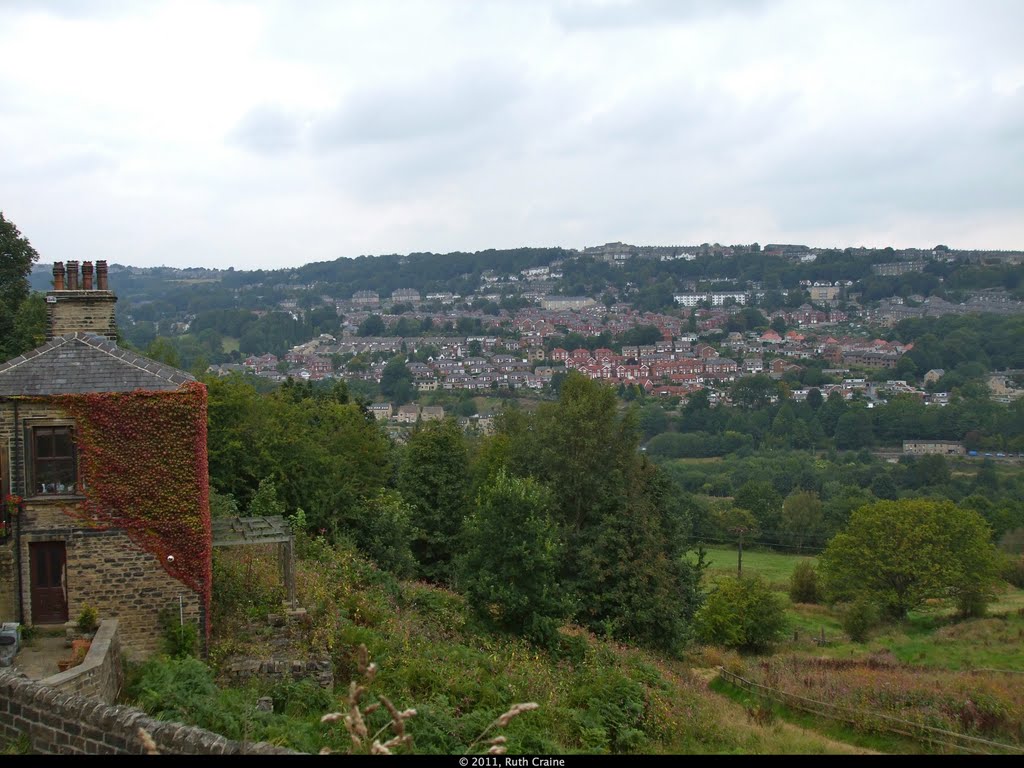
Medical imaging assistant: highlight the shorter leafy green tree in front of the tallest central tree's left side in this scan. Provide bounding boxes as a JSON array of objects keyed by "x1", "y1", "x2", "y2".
[{"x1": 457, "y1": 470, "x2": 569, "y2": 646}]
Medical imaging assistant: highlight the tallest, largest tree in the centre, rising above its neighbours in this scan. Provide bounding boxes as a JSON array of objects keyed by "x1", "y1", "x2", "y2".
[{"x1": 498, "y1": 371, "x2": 699, "y2": 649}]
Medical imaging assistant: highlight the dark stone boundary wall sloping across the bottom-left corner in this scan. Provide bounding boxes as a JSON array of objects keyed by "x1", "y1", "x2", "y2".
[{"x1": 0, "y1": 671, "x2": 302, "y2": 755}]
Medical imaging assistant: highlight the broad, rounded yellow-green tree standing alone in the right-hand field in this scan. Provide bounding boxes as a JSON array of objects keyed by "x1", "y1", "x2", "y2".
[{"x1": 818, "y1": 499, "x2": 998, "y2": 618}]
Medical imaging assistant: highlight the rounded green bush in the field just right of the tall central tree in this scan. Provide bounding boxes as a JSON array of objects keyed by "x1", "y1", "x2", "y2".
[{"x1": 694, "y1": 575, "x2": 786, "y2": 651}]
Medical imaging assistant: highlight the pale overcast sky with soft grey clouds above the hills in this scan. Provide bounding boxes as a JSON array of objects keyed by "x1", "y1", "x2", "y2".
[{"x1": 0, "y1": 0, "x2": 1024, "y2": 269}]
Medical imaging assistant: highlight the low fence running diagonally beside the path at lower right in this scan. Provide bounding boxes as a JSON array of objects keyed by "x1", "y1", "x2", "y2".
[{"x1": 718, "y1": 667, "x2": 1024, "y2": 755}]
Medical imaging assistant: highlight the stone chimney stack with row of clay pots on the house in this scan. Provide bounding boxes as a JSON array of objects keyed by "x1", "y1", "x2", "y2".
[{"x1": 46, "y1": 261, "x2": 118, "y2": 343}]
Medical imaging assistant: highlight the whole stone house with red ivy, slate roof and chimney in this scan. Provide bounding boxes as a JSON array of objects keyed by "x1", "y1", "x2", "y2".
[{"x1": 0, "y1": 261, "x2": 212, "y2": 658}]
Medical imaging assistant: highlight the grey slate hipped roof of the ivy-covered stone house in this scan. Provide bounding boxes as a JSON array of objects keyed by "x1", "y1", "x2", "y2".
[{"x1": 0, "y1": 333, "x2": 196, "y2": 397}]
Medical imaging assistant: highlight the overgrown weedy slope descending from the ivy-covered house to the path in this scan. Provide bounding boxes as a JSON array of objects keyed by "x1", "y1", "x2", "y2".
[{"x1": 121, "y1": 540, "x2": 880, "y2": 755}]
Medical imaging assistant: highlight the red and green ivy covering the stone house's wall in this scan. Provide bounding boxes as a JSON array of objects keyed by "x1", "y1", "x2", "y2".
[{"x1": 47, "y1": 382, "x2": 213, "y2": 632}]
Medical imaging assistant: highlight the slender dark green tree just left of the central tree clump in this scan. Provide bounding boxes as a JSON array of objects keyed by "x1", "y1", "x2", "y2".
[{"x1": 397, "y1": 419, "x2": 469, "y2": 583}]
